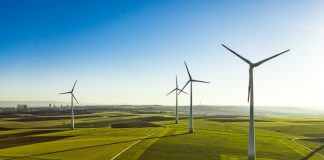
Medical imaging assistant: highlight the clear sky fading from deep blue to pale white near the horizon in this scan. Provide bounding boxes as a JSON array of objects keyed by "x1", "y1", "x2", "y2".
[{"x1": 0, "y1": 0, "x2": 324, "y2": 107}]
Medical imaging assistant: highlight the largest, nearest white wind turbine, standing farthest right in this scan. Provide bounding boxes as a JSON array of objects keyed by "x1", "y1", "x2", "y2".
[{"x1": 222, "y1": 44, "x2": 290, "y2": 160}]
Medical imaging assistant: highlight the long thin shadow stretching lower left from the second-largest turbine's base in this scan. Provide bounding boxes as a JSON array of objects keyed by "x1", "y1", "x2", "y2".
[{"x1": 5, "y1": 132, "x2": 188, "y2": 160}]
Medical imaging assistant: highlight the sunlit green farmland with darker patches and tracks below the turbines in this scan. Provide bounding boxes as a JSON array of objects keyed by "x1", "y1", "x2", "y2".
[{"x1": 0, "y1": 111, "x2": 324, "y2": 160}]
